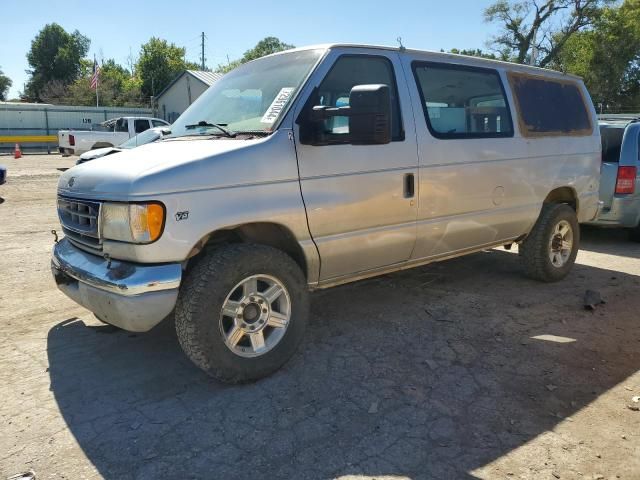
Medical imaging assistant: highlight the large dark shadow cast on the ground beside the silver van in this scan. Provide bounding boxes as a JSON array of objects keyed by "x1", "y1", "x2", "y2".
[{"x1": 48, "y1": 246, "x2": 640, "y2": 480}]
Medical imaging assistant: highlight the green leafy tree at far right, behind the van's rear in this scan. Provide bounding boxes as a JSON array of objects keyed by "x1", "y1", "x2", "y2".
[{"x1": 553, "y1": 0, "x2": 640, "y2": 110}]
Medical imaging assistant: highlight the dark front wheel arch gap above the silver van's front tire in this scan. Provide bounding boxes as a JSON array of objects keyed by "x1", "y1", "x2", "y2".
[{"x1": 189, "y1": 222, "x2": 310, "y2": 279}]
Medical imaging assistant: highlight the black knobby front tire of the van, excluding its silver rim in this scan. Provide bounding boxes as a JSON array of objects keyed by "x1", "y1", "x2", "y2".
[{"x1": 175, "y1": 244, "x2": 309, "y2": 383}]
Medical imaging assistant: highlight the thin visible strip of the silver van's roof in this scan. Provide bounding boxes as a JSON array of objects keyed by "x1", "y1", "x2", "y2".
[{"x1": 264, "y1": 43, "x2": 582, "y2": 80}]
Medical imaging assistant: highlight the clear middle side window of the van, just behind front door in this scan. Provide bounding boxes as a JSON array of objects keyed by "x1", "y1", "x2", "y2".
[{"x1": 413, "y1": 62, "x2": 513, "y2": 139}]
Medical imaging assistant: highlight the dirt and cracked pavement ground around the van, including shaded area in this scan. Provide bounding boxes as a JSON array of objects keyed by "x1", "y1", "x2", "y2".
[{"x1": 0, "y1": 155, "x2": 640, "y2": 480}]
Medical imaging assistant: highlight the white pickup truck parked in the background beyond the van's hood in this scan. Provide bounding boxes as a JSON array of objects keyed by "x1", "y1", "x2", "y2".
[{"x1": 58, "y1": 117, "x2": 169, "y2": 156}]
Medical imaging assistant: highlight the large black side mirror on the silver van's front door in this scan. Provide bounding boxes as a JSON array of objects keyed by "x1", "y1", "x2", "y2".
[{"x1": 349, "y1": 85, "x2": 391, "y2": 145}]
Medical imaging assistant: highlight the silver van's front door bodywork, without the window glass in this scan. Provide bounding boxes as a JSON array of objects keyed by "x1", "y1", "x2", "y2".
[{"x1": 295, "y1": 48, "x2": 418, "y2": 280}]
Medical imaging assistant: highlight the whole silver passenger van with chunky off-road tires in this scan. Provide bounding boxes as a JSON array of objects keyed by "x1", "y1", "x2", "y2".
[{"x1": 52, "y1": 45, "x2": 600, "y2": 382}]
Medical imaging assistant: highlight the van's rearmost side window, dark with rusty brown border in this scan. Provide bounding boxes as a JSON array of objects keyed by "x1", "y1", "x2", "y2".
[{"x1": 509, "y1": 72, "x2": 593, "y2": 137}]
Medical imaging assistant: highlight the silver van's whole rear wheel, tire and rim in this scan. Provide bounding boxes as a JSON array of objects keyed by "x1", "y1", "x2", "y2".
[{"x1": 519, "y1": 204, "x2": 580, "y2": 282}]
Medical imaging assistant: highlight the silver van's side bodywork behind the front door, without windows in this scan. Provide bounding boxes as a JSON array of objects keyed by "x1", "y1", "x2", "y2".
[{"x1": 404, "y1": 54, "x2": 599, "y2": 260}]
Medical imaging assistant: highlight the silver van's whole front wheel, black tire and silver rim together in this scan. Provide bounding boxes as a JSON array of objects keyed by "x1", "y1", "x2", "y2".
[{"x1": 176, "y1": 244, "x2": 309, "y2": 383}]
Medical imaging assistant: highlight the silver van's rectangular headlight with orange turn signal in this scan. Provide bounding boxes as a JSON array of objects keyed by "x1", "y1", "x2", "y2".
[{"x1": 100, "y1": 202, "x2": 164, "y2": 243}]
